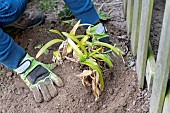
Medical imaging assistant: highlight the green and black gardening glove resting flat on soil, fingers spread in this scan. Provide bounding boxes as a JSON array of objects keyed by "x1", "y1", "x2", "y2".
[{"x1": 14, "y1": 54, "x2": 63, "y2": 102}]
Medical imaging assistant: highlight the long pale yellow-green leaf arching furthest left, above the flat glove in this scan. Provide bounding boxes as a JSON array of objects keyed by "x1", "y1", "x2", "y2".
[{"x1": 36, "y1": 39, "x2": 63, "y2": 58}]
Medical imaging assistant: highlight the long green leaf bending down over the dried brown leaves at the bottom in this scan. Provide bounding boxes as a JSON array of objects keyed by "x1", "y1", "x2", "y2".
[{"x1": 81, "y1": 59, "x2": 104, "y2": 90}]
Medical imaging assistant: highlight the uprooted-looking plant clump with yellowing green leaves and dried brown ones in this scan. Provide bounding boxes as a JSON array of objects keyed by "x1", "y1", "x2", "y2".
[{"x1": 36, "y1": 21, "x2": 122, "y2": 100}]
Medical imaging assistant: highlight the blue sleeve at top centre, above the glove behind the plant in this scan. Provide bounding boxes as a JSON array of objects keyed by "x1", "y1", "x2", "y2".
[{"x1": 64, "y1": 0, "x2": 99, "y2": 24}]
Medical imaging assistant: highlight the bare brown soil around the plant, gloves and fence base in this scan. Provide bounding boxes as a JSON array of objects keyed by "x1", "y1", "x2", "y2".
[{"x1": 0, "y1": 0, "x2": 150, "y2": 113}]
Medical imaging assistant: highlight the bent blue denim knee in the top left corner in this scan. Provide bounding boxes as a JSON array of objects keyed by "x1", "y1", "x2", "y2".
[{"x1": 0, "y1": 0, "x2": 28, "y2": 26}]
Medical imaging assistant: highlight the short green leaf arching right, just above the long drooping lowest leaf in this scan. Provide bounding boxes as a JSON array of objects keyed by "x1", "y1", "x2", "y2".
[{"x1": 93, "y1": 54, "x2": 113, "y2": 67}]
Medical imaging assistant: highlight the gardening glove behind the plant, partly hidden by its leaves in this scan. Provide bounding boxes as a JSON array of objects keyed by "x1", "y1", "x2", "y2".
[{"x1": 90, "y1": 23, "x2": 116, "y2": 61}]
